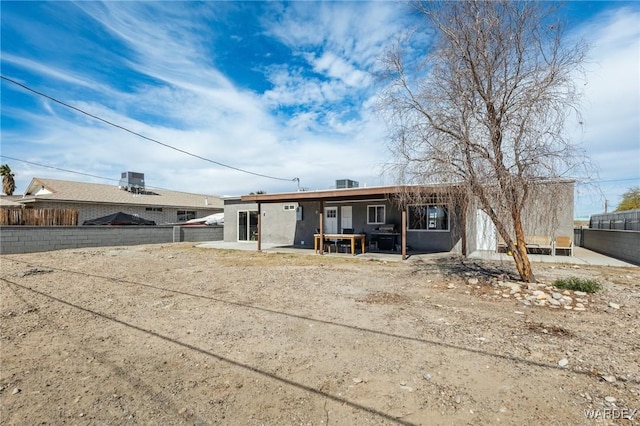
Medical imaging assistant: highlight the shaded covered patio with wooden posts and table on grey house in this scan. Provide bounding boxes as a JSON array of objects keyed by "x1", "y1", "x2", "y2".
[{"x1": 241, "y1": 185, "x2": 466, "y2": 260}]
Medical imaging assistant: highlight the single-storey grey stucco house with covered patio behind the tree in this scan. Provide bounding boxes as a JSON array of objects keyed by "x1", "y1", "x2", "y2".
[{"x1": 229, "y1": 181, "x2": 573, "y2": 255}]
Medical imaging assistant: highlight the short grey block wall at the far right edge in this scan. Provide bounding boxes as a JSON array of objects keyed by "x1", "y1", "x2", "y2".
[{"x1": 582, "y1": 229, "x2": 640, "y2": 265}]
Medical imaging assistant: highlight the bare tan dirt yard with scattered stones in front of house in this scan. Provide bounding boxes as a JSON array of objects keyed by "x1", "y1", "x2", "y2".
[{"x1": 0, "y1": 244, "x2": 640, "y2": 425}]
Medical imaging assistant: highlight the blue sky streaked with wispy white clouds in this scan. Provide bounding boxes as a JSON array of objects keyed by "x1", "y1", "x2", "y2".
[{"x1": 0, "y1": 1, "x2": 640, "y2": 216}]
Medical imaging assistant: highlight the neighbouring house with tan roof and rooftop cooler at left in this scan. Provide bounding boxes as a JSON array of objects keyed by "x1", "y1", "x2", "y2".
[{"x1": 13, "y1": 172, "x2": 223, "y2": 225}]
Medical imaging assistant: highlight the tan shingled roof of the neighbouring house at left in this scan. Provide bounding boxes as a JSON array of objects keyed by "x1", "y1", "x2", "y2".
[{"x1": 20, "y1": 178, "x2": 223, "y2": 209}]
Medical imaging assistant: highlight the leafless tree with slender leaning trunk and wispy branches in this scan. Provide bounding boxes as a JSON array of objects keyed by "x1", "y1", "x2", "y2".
[{"x1": 382, "y1": 0, "x2": 590, "y2": 282}]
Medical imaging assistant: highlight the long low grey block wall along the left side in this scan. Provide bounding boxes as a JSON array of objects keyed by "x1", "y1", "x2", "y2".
[{"x1": 0, "y1": 226, "x2": 223, "y2": 254}]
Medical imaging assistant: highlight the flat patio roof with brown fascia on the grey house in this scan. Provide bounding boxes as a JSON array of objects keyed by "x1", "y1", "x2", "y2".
[{"x1": 240, "y1": 184, "x2": 457, "y2": 203}]
